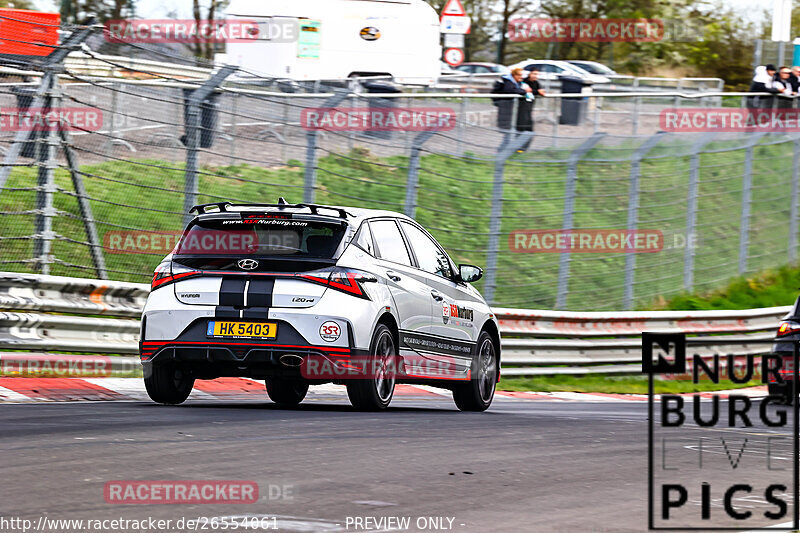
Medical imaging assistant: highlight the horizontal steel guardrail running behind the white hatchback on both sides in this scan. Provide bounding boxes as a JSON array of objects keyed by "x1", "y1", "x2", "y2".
[{"x1": 0, "y1": 272, "x2": 791, "y2": 376}]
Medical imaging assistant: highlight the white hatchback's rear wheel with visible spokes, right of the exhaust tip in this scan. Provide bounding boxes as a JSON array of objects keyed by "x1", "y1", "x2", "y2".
[{"x1": 347, "y1": 324, "x2": 397, "y2": 411}]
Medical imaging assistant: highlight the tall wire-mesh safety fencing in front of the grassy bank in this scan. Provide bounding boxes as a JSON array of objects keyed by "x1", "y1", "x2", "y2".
[{"x1": 0, "y1": 22, "x2": 800, "y2": 310}]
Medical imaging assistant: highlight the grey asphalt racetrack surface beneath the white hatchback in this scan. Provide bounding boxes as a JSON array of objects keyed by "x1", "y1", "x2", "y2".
[{"x1": 0, "y1": 390, "x2": 792, "y2": 532}]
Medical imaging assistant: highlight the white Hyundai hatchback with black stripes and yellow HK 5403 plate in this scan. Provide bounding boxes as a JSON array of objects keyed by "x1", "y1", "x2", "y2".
[{"x1": 141, "y1": 198, "x2": 500, "y2": 411}]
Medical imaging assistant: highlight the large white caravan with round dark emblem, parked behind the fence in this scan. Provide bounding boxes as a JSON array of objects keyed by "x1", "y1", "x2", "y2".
[{"x1": 222, "y1": 0, "x2": 442, "y2": 85}]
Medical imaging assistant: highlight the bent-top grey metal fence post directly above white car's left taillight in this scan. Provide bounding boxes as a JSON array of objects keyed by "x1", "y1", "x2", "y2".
[{"x1": 183, "y1": 65, "x2": 237, "y2": 226}]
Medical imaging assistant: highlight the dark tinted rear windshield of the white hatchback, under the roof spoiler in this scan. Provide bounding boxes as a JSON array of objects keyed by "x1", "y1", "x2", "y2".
[{"x1": 175, "y1": 215, "x2": 346, "y2": 259}]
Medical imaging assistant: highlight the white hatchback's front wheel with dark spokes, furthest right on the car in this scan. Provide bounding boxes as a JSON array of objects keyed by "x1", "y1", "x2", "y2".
[{"x1": 453, "y1": 331, "x2": 498, "y2": 411}]
